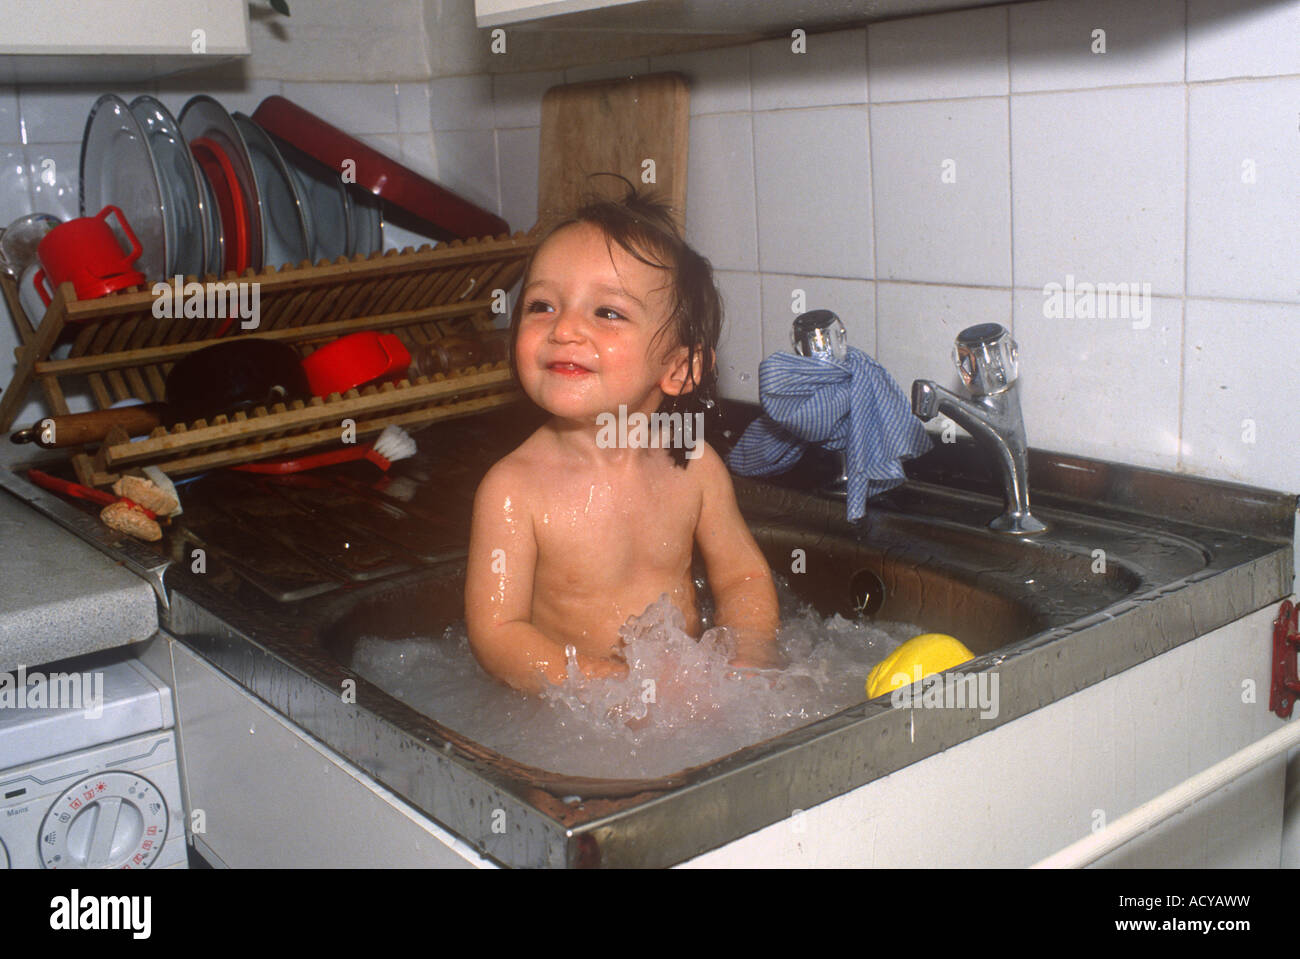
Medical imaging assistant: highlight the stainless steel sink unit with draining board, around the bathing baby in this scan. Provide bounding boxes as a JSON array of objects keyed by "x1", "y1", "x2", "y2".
[{"x1": 3, "y1": 400, "x2": 1296, "y2": 867}]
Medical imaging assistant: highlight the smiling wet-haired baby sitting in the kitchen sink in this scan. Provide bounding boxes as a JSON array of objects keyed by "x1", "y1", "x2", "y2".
[{"x1": 465, "y1": 185, "x2": 777, "y2": 691}]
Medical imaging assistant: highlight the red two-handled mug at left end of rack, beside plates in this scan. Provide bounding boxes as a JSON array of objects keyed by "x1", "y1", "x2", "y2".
[{"x1": 35, "y1": 207, "x2": 144, "y2": 307}]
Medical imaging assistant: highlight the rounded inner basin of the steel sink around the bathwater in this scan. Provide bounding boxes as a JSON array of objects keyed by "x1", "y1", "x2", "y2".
[{"x1": 312, "y1": 467, "x2": 1206, "y2": 798}]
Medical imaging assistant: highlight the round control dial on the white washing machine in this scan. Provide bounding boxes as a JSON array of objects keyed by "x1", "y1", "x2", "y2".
[{"x1": 36, "y1": 772, "x2": 168, "y2": 869}]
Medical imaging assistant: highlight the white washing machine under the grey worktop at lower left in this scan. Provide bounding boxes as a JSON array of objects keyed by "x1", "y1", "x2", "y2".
[{"x1": 0, "y1": 648, "x2": 189, "y2": 869}]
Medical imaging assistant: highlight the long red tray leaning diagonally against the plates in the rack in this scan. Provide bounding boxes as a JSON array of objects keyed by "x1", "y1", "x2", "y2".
[{"x1": 252, "y1": 96, "x2": 510, "y2": 239}]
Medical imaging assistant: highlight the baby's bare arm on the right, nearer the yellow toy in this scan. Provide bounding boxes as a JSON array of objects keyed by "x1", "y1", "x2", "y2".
[{"x1": 688, "y1": 444, "x2": 780, "y2": 667}]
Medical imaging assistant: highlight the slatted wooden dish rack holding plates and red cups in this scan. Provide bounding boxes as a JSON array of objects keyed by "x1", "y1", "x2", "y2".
[{"x1": 0, "y1": 230, "x2": 537, "y2": 486}]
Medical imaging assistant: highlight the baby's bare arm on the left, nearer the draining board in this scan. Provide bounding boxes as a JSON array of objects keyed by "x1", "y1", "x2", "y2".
[{"x1": 465, "y1": 460, "x2": 625, "y2": 693}]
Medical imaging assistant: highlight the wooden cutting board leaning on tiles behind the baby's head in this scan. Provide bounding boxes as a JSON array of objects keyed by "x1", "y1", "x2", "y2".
[{"x1": 537, "y1": 73, "x2": 690, "y2": 231}]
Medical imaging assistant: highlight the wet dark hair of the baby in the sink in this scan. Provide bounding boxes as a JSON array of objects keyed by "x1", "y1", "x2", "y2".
[{"x1": 511, "y1": 173, "x2": 723, "y2": 467}]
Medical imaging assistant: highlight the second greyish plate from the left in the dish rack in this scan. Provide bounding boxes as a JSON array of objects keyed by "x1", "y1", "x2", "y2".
[{"x1": 130, "y1": 96, "x2": 208, "y2": 277}]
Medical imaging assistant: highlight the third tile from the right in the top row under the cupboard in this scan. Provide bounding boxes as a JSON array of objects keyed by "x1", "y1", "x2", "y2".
[{"x1": 867, "y1": 6, "x2": 1009, "y2": 103}]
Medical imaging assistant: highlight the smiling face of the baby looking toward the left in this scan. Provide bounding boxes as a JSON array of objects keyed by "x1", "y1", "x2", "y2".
[{"x1": 515, "y1": 224, "x2": 685, "y2": 420}]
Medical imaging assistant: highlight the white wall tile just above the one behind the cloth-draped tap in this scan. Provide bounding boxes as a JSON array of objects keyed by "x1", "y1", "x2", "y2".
[{"x1": 754, "y1": 107, "x2": 874, "y2": 278}]
